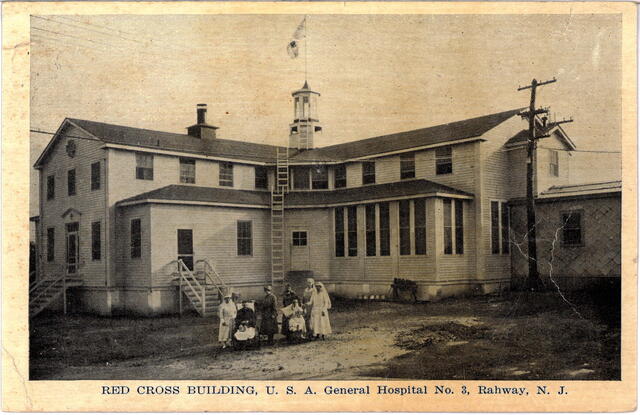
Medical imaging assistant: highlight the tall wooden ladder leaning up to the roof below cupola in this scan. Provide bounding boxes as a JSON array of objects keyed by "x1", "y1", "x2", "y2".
[{"x1": 271, "y1": 147, "x2": 289, "y2": 286}]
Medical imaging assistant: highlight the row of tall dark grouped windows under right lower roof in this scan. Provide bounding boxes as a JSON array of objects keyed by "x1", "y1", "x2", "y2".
[{"x1": 334, "y1": 198, "x2": 464, "y2": 257}]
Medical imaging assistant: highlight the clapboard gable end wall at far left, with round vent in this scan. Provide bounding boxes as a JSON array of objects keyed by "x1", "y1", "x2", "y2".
[{"x1": 40, "y1": 126, "x2": 107, "y2": 287}]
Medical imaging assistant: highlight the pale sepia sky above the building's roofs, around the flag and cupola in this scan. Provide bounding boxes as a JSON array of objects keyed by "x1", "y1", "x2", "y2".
[{"x1": 30, "y1": 14, "x2": 621, "y2": 215}]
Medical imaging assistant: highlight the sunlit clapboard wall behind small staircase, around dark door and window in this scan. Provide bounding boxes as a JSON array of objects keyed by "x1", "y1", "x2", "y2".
[{"x1": 151, "y1": 205, "x2": 271, "y2": 286}]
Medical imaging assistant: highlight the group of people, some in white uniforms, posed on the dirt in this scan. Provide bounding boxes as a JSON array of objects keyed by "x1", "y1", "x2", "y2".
[{"x1": 218, "y1": 278, "x2": 331, "y2": 348}]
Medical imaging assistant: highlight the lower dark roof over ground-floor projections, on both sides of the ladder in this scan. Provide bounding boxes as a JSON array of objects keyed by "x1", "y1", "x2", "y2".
[{"x1": 117, "y1": 179, "x2": 473, "y2": 208}]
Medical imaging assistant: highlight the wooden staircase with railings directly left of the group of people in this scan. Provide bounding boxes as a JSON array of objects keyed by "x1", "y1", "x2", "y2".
[{"x1": 175, "y1": 260, "x2": 229, "y2": 317}]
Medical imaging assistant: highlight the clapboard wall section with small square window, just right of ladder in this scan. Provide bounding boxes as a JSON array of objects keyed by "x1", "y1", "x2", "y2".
[{"x1": 284, "y1": 209, "x2": 333, "y2": 277}]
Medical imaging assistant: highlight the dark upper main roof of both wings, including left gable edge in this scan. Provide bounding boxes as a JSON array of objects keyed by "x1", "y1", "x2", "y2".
[{"x1": 35, "y1": 109, "x2": 520, "y2": 168}]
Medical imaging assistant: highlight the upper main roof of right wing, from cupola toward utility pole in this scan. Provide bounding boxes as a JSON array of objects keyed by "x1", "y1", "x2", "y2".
[{"x1": 291, "y1": 109, "x2": 520, "y2": 162}]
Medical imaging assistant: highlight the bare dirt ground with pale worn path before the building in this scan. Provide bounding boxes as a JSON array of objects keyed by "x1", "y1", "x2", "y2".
[{"x1": 30, "y1": 291, "x2": 620, "y2": 380}]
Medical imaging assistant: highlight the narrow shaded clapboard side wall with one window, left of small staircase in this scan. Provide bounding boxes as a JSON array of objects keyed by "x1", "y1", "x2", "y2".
[{"x1": 114, "y1": 205, "x2": 151, "y2": 288}]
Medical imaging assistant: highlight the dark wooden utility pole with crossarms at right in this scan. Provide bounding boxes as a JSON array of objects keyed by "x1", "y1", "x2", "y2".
[{"x1": 518, "y1": 78, "x2": 556, "y2": 291}]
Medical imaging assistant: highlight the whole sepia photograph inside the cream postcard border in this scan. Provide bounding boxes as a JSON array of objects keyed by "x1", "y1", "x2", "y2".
[{"x1": 26, "y1": 12, "x2": 624, "y2": 384}]
